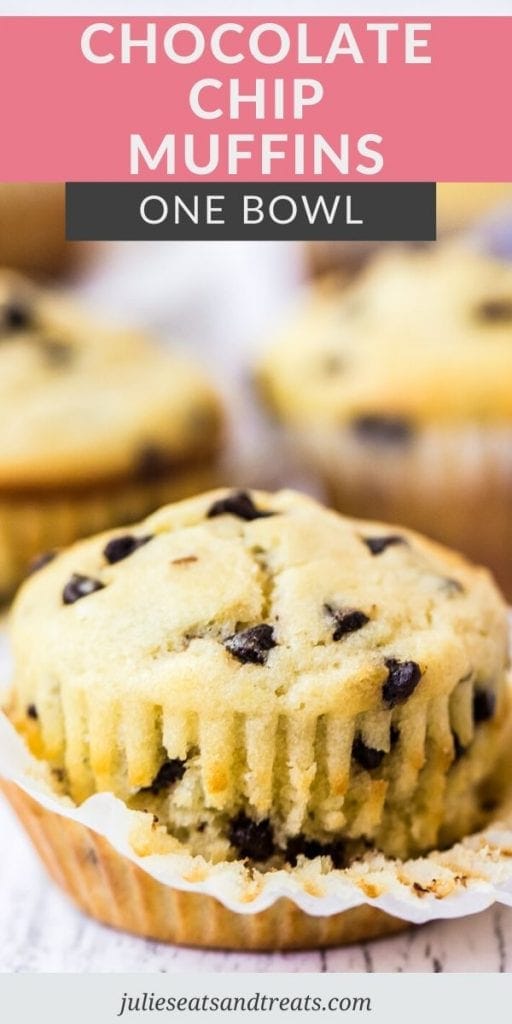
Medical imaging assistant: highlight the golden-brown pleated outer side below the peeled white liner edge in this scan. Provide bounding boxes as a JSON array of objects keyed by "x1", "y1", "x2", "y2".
[{"x1": 0, "y1": 780, "x2": 412, "y2": 950}]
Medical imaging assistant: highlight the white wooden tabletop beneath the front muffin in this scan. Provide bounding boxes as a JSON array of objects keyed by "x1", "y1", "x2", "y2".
[{"x1": 0, "y1": 801, "x2": 512, "y2": 974}]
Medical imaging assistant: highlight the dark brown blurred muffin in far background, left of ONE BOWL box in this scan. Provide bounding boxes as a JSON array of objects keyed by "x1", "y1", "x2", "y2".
[{"x1": 0, "y1": 181, "x2": 77, "y2": 276}]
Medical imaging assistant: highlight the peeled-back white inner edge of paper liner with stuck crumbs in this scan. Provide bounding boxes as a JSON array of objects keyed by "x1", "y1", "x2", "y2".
[{"x1": 0, "y1": 671, "x2": 512, "y2": 924}]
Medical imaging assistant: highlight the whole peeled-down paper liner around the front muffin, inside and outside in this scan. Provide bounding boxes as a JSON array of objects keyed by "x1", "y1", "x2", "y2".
[{"x1": 0, "y1": 715, "x2": 512, "y2": 949}]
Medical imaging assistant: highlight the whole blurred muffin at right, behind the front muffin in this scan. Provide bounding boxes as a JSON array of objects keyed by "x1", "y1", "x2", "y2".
[{"x1": 257, "y1": 244, "x2": 512, "y2": 595}]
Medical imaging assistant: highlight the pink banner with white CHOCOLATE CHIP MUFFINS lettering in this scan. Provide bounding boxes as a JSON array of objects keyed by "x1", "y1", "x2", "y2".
[{"x1": 0, "y1": 14, "x2": 512, "y2": 181}]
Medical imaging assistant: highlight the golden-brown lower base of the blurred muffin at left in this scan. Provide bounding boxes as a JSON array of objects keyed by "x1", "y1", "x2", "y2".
[{"x1": 0, "y1": 459, "x2": 218, "y2": 605}]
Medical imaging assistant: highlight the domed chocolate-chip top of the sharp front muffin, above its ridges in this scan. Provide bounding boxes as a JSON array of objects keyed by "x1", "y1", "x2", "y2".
[{"x1": 12, "y1": 490, "x2": 507, "y2": 718}]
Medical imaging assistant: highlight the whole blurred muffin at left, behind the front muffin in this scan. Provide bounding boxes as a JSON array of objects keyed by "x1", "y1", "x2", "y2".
[{"x1": 0, "y1": 271, "x2": 221, "y2": 600}]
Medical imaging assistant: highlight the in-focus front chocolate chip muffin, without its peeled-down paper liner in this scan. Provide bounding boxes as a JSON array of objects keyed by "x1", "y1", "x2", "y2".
[{"x1": 9, "y1": 483, "x2": 508, "y2": 870}]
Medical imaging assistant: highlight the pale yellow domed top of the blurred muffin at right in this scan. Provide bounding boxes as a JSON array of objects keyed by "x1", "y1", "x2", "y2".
[{"x1": 258, "y1": 245, "x2": 512, "y2": 425}]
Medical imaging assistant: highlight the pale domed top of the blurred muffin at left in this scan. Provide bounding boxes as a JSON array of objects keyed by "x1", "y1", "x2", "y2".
[{"x1": 0, "y1": 271, "x2": 220, "y2": 490}]
